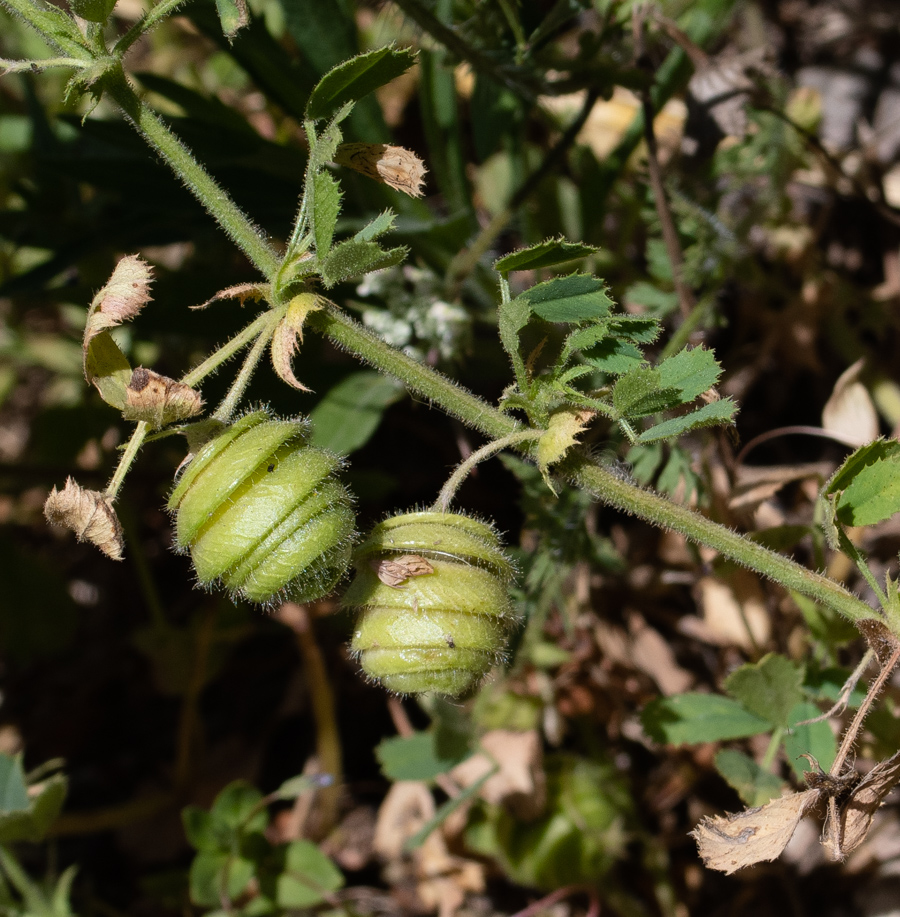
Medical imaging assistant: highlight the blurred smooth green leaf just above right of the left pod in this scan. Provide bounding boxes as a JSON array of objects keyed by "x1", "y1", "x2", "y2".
[{"x1": 310, "y1": 370, "x2": 405, "y2": 455}]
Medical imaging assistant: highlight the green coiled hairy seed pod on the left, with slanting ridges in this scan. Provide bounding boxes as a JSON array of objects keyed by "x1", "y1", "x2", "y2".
[{"x1": 169, "y1": 411, "x2": 354, "y2": 604}]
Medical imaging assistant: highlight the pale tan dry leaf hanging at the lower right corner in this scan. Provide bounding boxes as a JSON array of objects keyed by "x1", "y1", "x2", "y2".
[{"x1": 691, "y1": 790, "x2": 821, "y2": 875}]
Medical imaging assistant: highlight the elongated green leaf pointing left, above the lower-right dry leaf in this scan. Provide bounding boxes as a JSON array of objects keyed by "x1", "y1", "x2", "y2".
[{"x1": 641, "y1": 693, "x2": 772, "y2": 745}]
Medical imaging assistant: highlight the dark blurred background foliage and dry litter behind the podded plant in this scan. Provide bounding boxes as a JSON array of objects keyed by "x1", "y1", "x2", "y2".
[{"x1": 0, "y1": 0, "x2": 900, "y2": 917}]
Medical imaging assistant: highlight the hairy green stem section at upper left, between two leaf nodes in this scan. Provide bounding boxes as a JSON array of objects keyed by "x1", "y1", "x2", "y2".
[{"x1": 102, "y1": 68, "x2": 280, "y2": 279}]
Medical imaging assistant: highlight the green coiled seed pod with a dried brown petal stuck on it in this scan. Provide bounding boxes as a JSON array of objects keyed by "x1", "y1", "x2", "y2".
[{"x1": 343, "y1": 512, "x2": 515, "y2": 695}]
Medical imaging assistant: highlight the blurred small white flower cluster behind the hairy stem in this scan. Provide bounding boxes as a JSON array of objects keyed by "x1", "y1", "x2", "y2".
[{"x1": 356, "y1": 265, "x2": 472, "y2": 361}]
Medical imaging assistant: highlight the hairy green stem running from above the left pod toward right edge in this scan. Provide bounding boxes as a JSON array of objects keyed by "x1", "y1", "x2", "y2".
[{"x1": 307, "y1": 308, "x2": 884, "y2": 621}]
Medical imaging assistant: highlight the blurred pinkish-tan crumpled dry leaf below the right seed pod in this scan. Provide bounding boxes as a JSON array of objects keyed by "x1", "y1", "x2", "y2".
[{"x1": 450, "y1": 729, "x2": 547, "y2": 821}]
